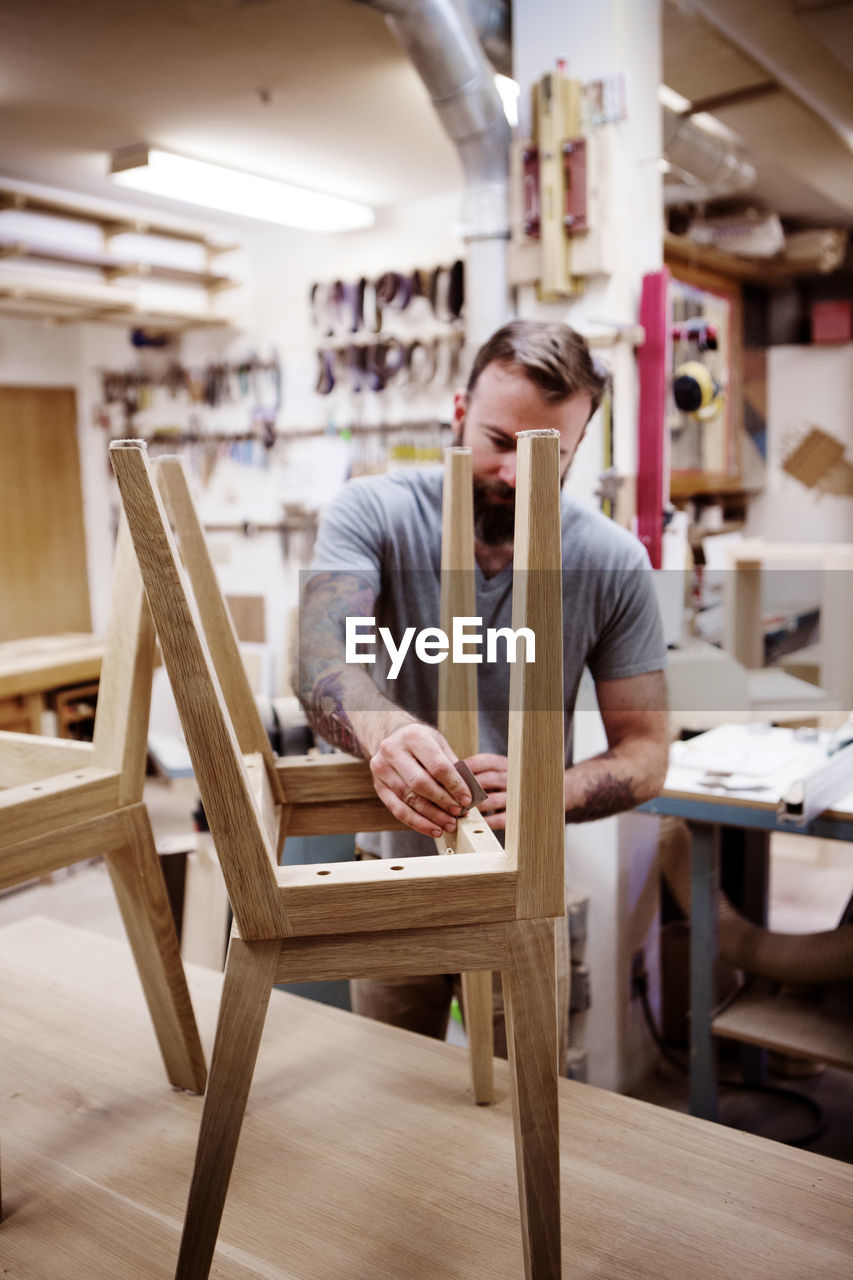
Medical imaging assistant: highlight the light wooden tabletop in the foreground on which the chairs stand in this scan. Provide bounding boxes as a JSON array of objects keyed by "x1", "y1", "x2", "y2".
[{"x1": 0, "y1": 918, "x2": 853, "y2": 1280}]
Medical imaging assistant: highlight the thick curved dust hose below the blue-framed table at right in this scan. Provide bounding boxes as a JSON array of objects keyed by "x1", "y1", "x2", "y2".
[{"x1": 658, "y1": 818, "x2": 853, "y2": 986}]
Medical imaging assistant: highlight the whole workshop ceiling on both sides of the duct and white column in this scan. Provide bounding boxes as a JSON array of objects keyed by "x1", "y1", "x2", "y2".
[{"x1": 0, "y1": 0, "x2": 853, "y2": 235}]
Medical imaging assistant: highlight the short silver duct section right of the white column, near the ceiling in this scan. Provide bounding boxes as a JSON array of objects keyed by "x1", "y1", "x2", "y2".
[{"x1": 662, "y1": 106, "x2": 756, "y2": 205}]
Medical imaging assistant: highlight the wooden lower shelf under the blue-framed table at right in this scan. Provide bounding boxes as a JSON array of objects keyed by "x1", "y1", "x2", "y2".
[{"x1": 711, "y1": 984, "x2": 853, "y2": 1071}]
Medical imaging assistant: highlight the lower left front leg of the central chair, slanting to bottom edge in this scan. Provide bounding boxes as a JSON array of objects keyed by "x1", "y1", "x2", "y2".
[{"x1": 175, "y1": 937, "x2": 282, "y2": 1280}]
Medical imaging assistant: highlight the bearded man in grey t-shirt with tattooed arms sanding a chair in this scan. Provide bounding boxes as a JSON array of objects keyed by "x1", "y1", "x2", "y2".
[{"x1": 296, "y1": 320, "x2": 669, "y2": 1069}]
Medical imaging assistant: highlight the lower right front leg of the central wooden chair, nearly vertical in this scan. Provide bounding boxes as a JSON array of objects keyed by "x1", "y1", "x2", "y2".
[{"x1": 502, "y1": 920, "x2": 561, "y2": 1280}]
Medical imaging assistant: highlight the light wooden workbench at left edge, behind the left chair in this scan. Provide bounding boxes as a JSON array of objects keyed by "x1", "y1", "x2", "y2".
[{"x1": 0, "y1": 634, "x2": 104, "y2": 733}]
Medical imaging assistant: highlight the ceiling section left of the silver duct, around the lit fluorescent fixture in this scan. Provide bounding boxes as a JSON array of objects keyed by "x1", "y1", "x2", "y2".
[{"x1": 0, "y1": 0, "x2": 461, "y2": 221}]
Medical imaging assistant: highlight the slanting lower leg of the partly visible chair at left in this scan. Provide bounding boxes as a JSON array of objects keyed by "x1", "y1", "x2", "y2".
[{"x1": 106, "y1": 804, "x2": 206, "y2": 1093}]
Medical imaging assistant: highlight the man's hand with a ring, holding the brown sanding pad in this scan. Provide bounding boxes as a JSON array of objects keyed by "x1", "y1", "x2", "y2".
[{"x1": 370, "y1": 721, "x2": 471, "y2": 840}]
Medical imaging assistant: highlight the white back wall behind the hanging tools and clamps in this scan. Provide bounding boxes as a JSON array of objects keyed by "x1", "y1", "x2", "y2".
[{"x1": 0, "y1": 186, "x2": 464, "y2": 711}]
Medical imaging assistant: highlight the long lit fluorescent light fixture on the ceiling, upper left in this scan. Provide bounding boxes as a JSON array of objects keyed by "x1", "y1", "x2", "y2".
[{"x1": 110, "y1": 146, "x2": 374, "y2": 232}]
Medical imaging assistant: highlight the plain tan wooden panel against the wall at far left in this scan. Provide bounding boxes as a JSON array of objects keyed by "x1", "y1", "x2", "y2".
[{"x1": 0, "y1": 387, "x2": 92, "y2": 641}]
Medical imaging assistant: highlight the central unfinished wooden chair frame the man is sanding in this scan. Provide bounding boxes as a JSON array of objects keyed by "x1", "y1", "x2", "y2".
[{"x1": 110, "y1": 431, "x2": 565, "y2": 1280}]
